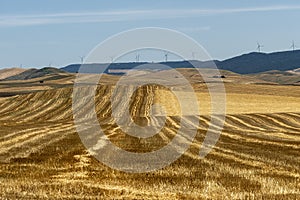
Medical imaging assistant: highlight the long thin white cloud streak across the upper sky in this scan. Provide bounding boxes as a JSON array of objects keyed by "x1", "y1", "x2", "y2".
[{"x1": 0, "y1": 5, "x2": 300, "y2": 27}]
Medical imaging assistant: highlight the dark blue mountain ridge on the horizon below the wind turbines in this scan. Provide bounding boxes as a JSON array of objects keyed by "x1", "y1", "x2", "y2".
[{"x1": 61, "y1": 50, "x2": 300, "y2": 74}]
